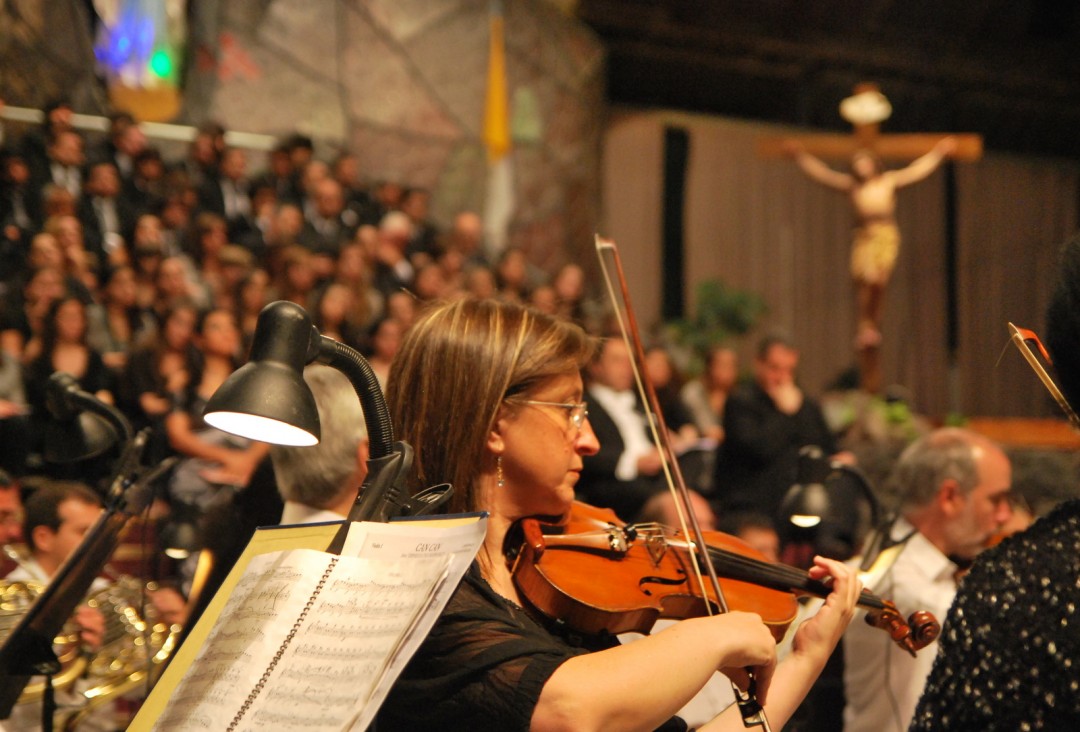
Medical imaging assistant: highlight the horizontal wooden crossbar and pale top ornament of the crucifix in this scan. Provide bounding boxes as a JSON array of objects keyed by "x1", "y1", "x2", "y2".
[{"x1": 757, "y1": 83, "x2": 983, "y2": 162}]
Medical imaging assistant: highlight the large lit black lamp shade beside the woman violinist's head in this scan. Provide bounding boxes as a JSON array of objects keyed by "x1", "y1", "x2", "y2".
[{"x1": 203, "y1": 301, "x2": 320, "y2": 446}]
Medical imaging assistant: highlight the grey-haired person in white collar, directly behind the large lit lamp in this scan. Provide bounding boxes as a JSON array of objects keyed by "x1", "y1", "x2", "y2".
[{"x1": 270, "y1": 365, "x2": 368, "y2": 524}]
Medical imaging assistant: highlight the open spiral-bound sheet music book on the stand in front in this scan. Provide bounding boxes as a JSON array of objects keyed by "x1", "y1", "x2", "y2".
[{"x1": 154, "y1": 550, "x2": 449, "y2": 732}]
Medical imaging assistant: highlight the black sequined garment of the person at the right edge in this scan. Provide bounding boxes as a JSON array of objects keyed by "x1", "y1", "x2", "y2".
[{"x1": 910, "y1": 501, "x2": 1080, "y2": 732}]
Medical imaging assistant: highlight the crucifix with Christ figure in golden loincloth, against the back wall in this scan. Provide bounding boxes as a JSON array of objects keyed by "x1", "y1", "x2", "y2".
[{"x1": 757, "y1": 83, "x2": 983, "y2": 393}]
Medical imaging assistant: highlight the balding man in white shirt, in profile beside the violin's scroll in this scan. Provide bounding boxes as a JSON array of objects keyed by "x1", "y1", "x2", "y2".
[{"x1": 843, "y1": 428, "x2": 1012, "y2": 732}]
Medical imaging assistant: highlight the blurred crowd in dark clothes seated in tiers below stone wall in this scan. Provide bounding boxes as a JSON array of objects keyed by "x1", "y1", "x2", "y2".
[{"x1": 0, "y1": 110, "x2": 635, "y2": 665}]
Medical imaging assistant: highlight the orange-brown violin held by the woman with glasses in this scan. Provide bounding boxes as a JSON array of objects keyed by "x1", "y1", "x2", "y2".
[{"x1": 509, "y1": 502, "x2": 941, "y2": 656}]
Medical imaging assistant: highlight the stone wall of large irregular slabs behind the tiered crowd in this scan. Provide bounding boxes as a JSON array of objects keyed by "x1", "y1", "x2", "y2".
[{"x1": 0, "y1": 0, "x2": 605, "y2": 269}]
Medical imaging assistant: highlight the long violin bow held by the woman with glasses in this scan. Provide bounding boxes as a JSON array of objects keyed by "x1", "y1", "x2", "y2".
[{"x1": 596, "y1": 235, "x2": 771, "y2": 732}]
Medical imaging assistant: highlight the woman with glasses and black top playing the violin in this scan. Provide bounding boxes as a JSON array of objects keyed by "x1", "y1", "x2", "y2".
[{"x1": 379, "y1": 300, "x2": 860, "y2": 730}]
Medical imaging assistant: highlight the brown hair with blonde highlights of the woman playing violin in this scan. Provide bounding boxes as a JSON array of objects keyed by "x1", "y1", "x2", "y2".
[{"x1": 387, "y1": 298, "x2": 595, "y2": 512}]
